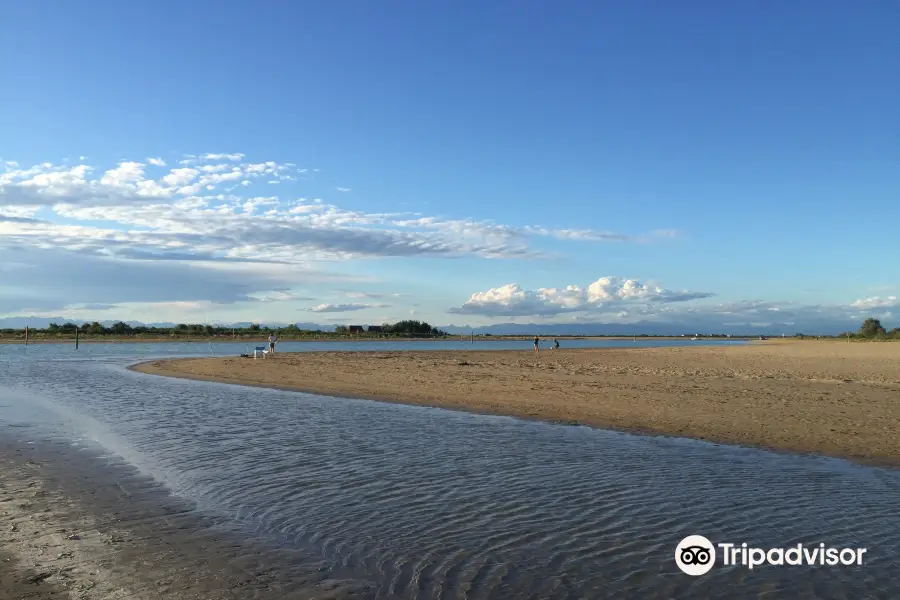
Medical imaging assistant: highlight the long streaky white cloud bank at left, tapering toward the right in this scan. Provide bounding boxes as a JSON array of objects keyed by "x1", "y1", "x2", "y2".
[{"x1": 0, "y1": 154, "x2": 668, "y2": 270}]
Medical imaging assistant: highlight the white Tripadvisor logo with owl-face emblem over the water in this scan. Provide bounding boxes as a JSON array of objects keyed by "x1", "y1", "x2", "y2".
[{"x1": 675, "y1": 535, "x2": 866, "y2": 576}]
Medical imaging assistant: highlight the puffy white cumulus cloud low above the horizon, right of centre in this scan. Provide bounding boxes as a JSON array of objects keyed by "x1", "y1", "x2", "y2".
[{"x1": 449, "y1": 277, "x2": 713, "y2": 316}]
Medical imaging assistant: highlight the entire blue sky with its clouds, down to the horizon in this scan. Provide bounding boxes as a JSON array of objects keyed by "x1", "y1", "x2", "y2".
[{"x1": 0, "y1": 0, "x2": 900, "y2": 332}]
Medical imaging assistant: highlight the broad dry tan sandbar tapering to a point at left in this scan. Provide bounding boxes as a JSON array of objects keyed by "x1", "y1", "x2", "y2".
[{"x1": 133, "y1": 341, "x2": 900, "y2": 467}]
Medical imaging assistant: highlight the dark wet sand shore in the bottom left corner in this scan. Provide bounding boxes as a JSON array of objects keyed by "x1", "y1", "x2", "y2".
[{"x1": 0, "y1": 437, "x2": 370, "y2": 600}]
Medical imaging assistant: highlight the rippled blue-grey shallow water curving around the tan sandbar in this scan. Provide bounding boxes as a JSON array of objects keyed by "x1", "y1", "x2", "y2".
[{"x1": 0, "y1": 342, "x2": 900, "y2": 599}]
